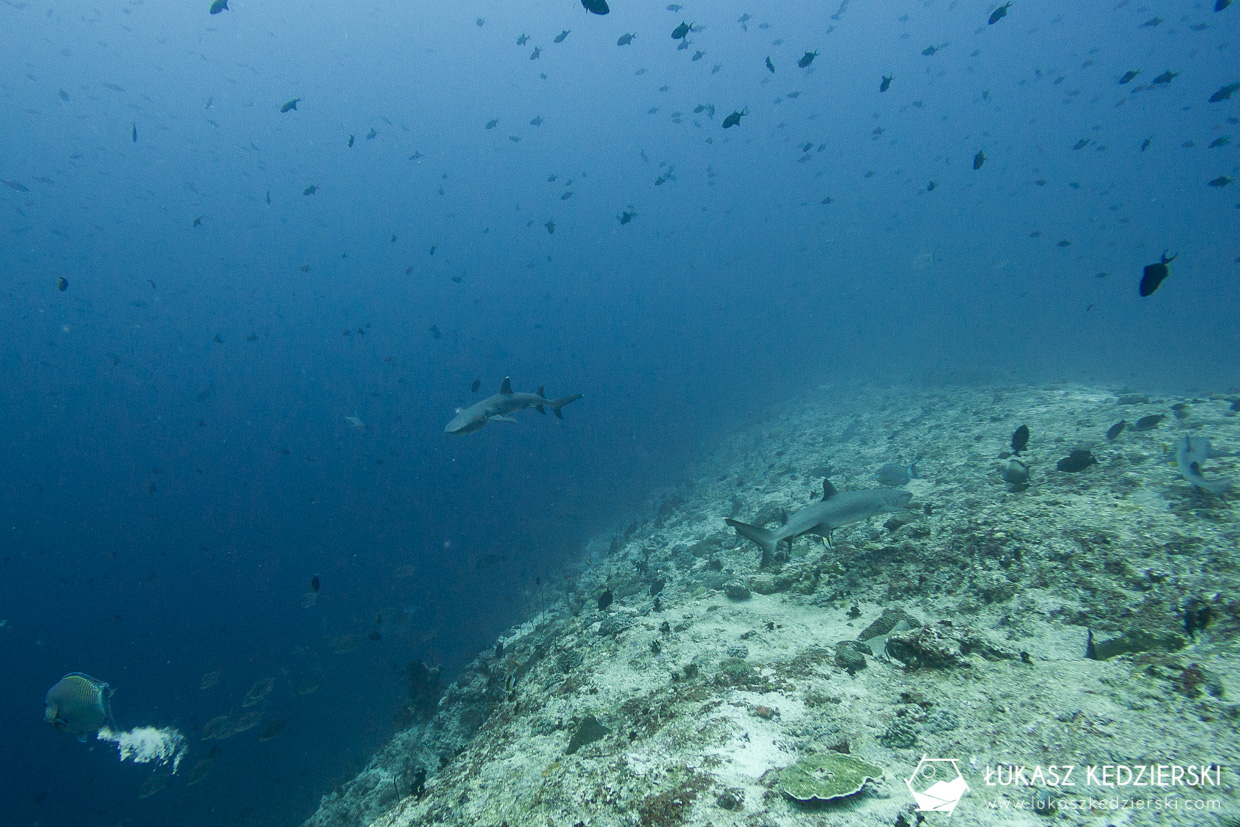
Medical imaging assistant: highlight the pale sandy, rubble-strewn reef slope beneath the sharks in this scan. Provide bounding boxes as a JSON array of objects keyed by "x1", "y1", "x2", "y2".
[{"x1": 306, "y1": 384, "x2": 1240, "y2": 827}]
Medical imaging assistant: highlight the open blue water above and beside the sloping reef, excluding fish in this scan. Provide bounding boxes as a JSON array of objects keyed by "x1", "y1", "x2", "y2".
[{"x1": 0, "y1": 0, "x2": 1240, "y2": 826}]
